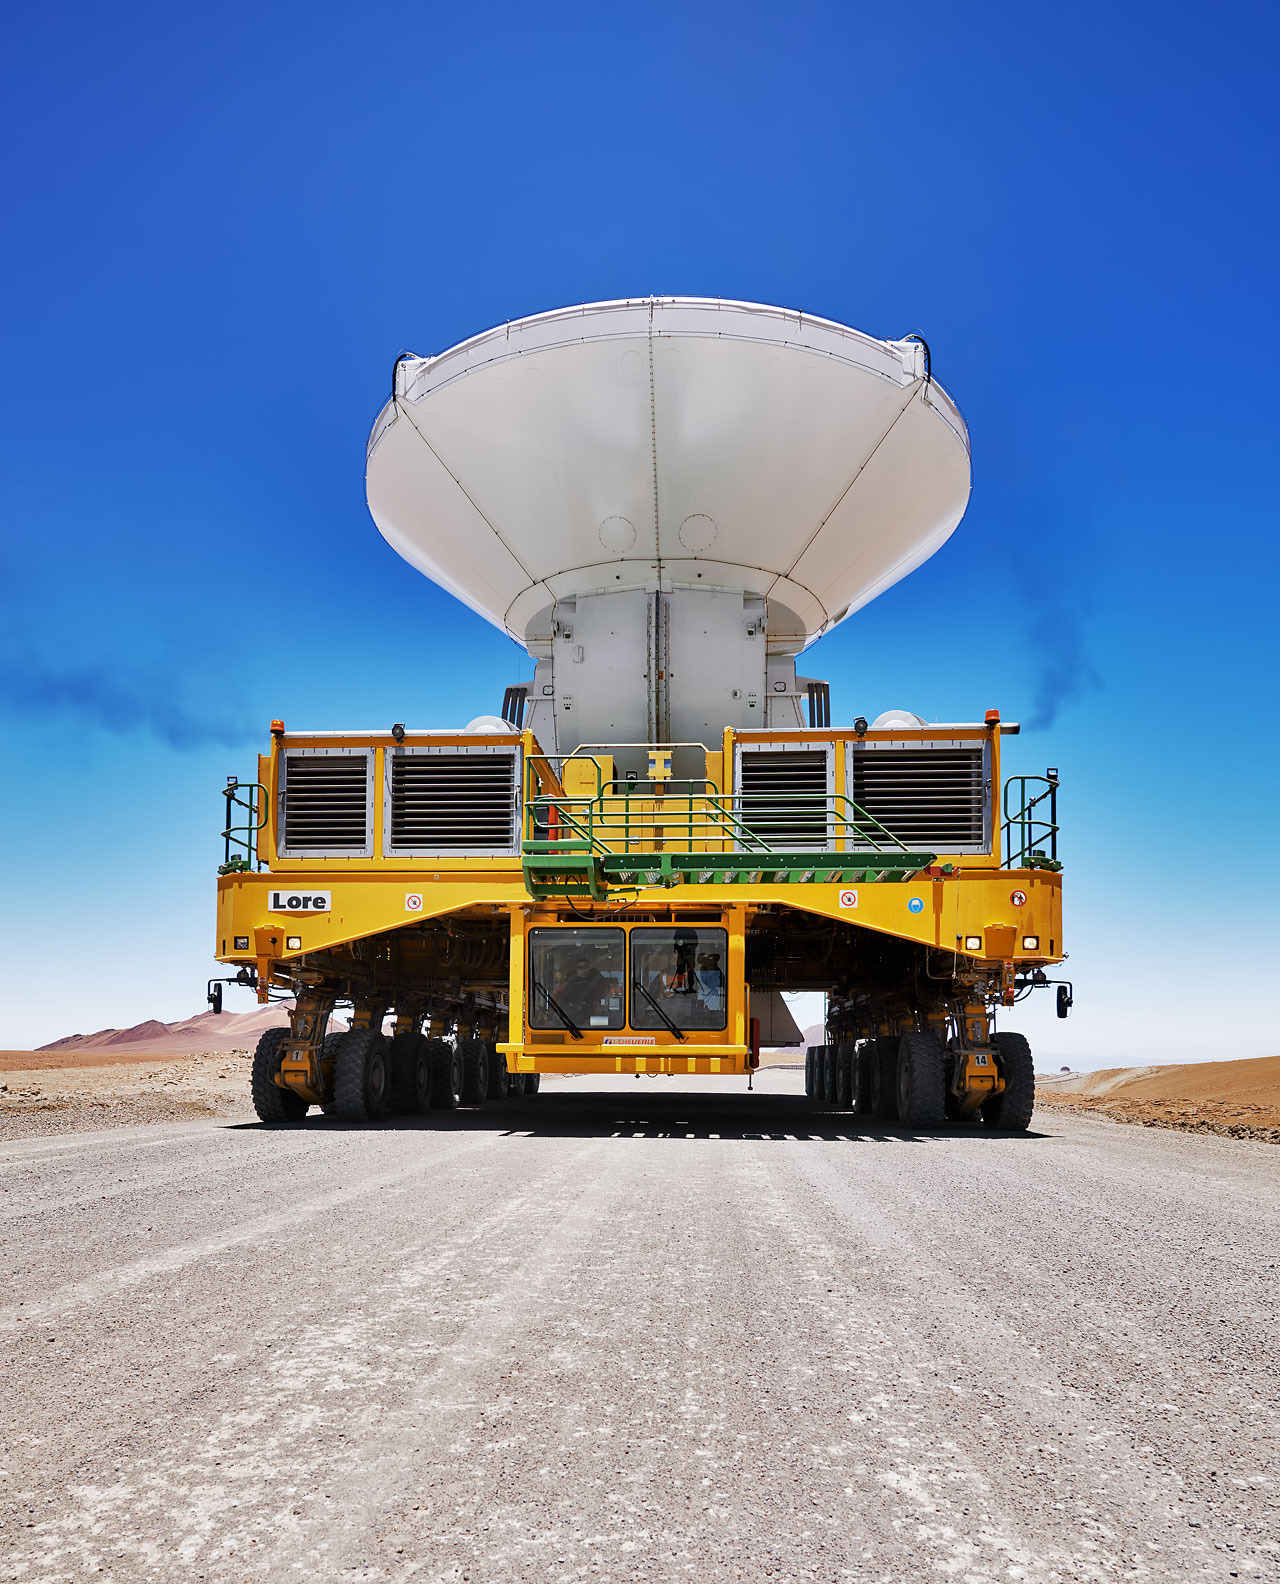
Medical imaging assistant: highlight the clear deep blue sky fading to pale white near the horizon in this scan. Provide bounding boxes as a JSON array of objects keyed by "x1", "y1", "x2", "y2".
[{"x1": 0, "y1": 3, "x2": 1280, "y2": 1066}]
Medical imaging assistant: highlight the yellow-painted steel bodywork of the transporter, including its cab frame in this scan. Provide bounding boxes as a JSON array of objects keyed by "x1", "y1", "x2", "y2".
[{"x1": 217, "y1": 725, "x2": 1065, "y2": 1088}]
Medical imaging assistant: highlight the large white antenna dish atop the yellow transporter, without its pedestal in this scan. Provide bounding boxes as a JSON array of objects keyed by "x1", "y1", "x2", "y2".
[{"x1": 366, "y1": 298, "x2": 970, "y2": 653}]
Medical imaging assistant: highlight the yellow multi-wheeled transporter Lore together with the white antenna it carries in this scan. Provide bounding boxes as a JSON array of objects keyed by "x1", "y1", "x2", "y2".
[{"x1": 217, "y1": 298, "x2": 1069, "y2": 1128}]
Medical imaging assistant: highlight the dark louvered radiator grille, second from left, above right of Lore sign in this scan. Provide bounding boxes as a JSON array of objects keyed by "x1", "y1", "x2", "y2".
[{"x1": 390, "y1": 754, "x2": 516, "y2": 852}]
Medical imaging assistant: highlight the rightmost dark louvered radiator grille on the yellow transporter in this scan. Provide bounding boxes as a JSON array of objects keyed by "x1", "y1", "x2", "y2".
[{"x1": 854, "y1": 748, "x2": 985, "y2": 852}]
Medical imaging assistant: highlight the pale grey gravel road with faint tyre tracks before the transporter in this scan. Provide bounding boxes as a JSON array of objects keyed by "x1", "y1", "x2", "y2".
[{"x1": 0, "y1": 1069, "x2": 1280, "y2": 1584}]
